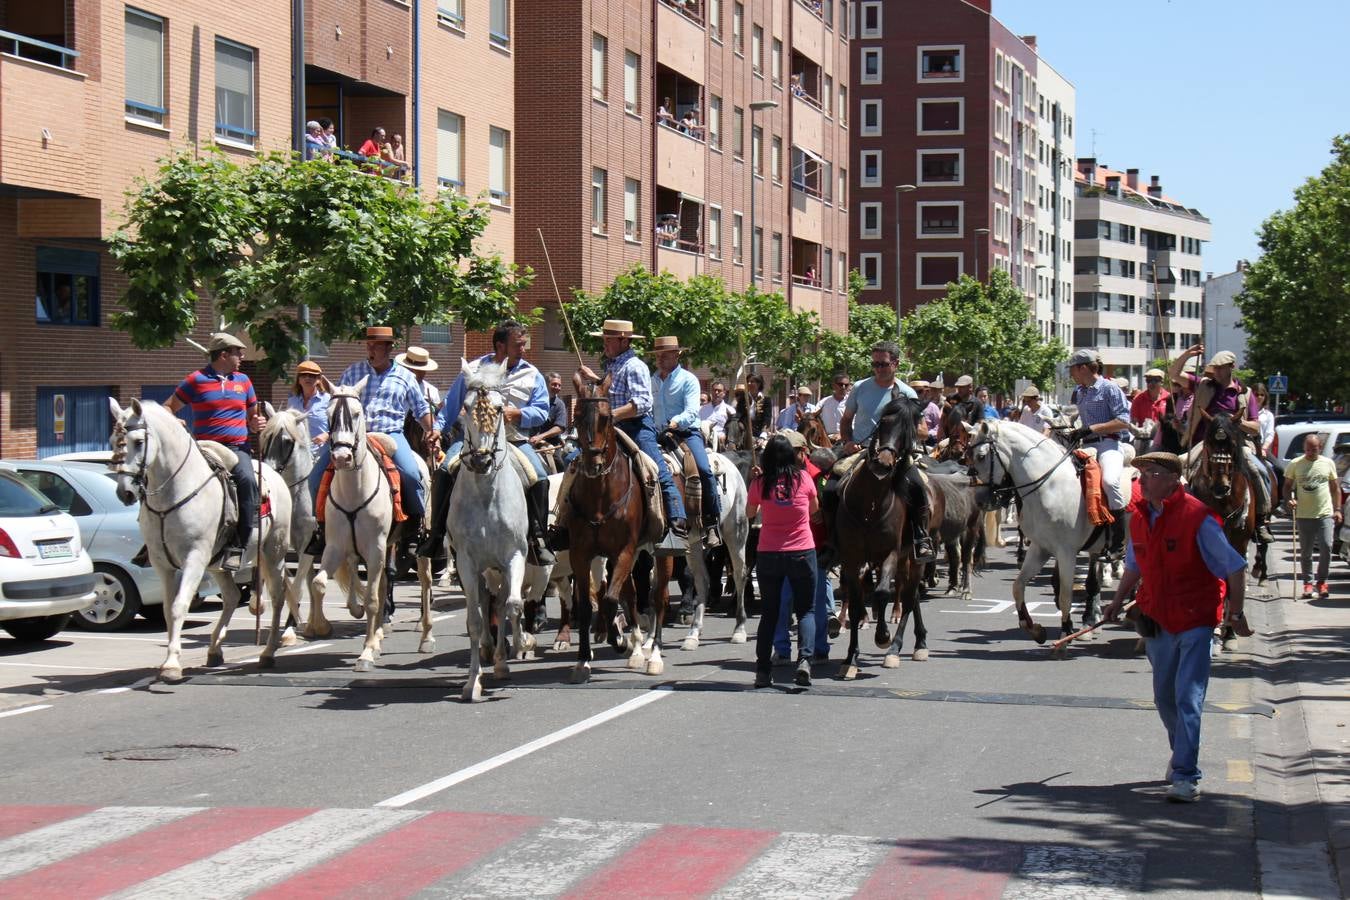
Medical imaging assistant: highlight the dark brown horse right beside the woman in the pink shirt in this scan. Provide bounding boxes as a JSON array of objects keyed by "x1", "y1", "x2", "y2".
[{"x1": 832, "y1": 397, "x2": 927, "y2": 679}]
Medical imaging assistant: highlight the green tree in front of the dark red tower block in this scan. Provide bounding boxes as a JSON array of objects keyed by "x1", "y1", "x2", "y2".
[{"x1": 900, "y1": 269, "x2": 1067, "y2": 391}]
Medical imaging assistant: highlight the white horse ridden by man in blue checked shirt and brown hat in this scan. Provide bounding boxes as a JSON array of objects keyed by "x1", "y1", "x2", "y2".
[{"x1": 311, "y1": 378, "x2": 394, "y2": 672}]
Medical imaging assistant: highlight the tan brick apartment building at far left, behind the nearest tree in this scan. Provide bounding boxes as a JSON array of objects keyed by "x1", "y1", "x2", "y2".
[{"x1": 0, "y1": 0, "x2": 516, "y2": 456}]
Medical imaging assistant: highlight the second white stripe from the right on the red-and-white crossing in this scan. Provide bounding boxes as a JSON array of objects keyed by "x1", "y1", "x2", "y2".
[{"x1": 713, "y1": 833, "x2": 892, "y2": 900}]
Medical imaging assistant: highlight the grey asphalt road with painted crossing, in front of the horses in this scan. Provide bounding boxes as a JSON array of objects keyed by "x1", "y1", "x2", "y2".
[{"x1": 0, "y1": 520, "x2": 1317, "y2": 896}]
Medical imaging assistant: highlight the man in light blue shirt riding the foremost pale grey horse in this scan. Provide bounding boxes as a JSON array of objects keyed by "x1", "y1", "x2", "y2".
[{"x1": 417, "y1": 320, "x2": 554, "y2": 565}]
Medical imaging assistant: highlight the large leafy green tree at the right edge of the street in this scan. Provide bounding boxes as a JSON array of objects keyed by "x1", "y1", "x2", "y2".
[{"x1": 1237, "y1": 135, "x2": 1350, "y2": 399}]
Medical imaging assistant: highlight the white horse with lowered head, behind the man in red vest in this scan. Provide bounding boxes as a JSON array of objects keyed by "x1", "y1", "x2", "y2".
[{"x1": 965, "y1": 420, "x2": 1107, "y2": 644}]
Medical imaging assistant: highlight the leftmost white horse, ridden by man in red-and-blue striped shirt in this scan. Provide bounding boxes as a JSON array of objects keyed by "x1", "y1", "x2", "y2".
[{"x1": 108, "y1": 398, "x2": 290, "y2": 681}]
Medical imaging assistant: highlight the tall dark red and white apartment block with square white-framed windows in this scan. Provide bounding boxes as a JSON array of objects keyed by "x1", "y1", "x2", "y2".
[{"x1": 851, "y1": 0, "x2": 1075, "y2": 327}]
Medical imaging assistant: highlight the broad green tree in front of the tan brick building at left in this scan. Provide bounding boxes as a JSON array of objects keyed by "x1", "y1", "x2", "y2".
[{"x1": 111, "y1": 151, "x2": 529, "y2": 375}]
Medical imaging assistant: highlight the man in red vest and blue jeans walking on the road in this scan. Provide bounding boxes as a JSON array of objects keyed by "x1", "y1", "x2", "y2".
[{"x1": 1106, "y1": 452, "x2": 1251, "y2": 803}]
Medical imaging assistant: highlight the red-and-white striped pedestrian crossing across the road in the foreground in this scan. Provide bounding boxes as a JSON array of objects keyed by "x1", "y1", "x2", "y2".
[{"x1": 0, "y1": 806, "x2": 1145, "y2": 900}]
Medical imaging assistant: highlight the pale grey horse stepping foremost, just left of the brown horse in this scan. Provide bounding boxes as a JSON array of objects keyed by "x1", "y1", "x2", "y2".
[{"x1": 448, "y1": 360, "x2": 529, "y2": 702}]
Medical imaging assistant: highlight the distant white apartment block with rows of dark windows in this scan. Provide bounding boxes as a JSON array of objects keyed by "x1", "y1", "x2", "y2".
[{"x1": 1073, "y1": 158, "x2": 1211, "y2": 387}]
